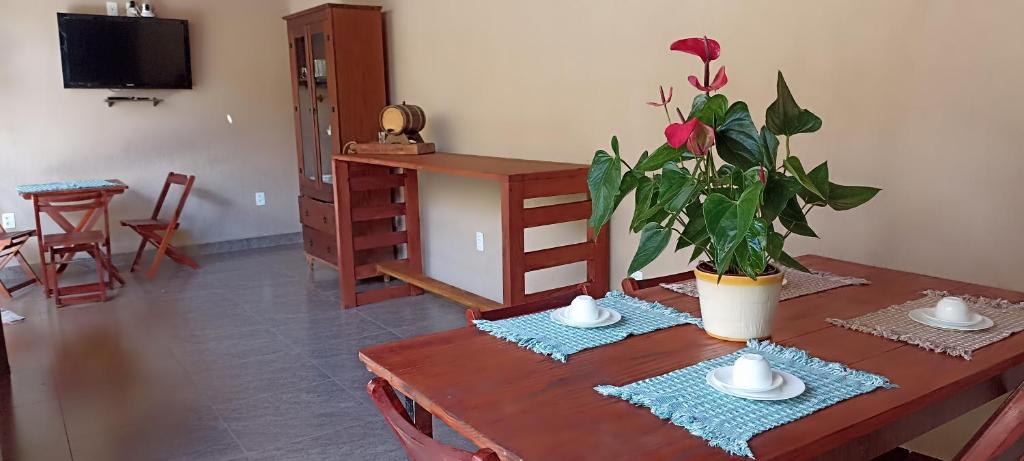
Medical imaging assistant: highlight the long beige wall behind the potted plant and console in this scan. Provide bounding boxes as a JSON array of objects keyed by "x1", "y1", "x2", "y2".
[{"x1": 384, "y1": 0, "x2": 1024, "y2": 295}]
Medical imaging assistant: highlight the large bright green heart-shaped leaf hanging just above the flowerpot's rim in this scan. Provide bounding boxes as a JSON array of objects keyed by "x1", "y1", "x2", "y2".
[{"x1": 703, "y1": 182, "x2": 763, "y2": 276}]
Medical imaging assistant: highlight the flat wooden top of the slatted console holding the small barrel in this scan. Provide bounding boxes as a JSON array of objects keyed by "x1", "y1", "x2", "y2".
[{"x1": 334, "y1": 152, "x2": 590, "y2": 180}]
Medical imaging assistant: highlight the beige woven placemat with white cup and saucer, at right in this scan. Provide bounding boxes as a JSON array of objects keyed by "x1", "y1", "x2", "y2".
[{"x1": 827, "y1": 290, "x2": 1024, "y2": 360}]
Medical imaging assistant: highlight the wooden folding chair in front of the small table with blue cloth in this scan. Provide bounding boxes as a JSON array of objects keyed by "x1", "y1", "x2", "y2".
[{"x1": 33, "y1": 192, "x2": 111, "y2": 307}]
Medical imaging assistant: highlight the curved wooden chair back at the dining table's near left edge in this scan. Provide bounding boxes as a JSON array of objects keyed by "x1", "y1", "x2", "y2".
[{"x1": 367, "y1": 378, "x2": 501, "y2": 461}]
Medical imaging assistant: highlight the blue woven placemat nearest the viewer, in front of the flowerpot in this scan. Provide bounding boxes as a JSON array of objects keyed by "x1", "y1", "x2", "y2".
[{"x1": 594, "y1": 340, "x2": 895, "y2": 458}]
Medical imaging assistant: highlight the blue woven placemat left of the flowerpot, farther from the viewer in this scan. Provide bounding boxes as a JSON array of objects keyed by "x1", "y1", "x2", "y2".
[{"x1": 474, "y1": 291, "x2": 702, "y2": 362}]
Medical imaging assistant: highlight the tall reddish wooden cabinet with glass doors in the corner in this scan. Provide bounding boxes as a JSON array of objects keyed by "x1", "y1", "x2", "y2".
[{"x1": 285, "y1": 4, "x2": 393, "y2": 266}]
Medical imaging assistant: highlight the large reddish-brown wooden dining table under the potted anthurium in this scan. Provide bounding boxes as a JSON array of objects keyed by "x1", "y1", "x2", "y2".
[{"x1": 359, "y1": 256, "x2": 1024, "y2": 461}]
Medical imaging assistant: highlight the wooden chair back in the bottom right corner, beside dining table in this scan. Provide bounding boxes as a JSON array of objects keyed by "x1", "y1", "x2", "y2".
[{"x1": 954, "y1": 383, "x2": 1024, "y2": 461}]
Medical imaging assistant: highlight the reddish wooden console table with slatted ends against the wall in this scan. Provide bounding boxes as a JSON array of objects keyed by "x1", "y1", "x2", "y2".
[{"x1": 332, "y1": 153, "x2": 609, "y2": 310}]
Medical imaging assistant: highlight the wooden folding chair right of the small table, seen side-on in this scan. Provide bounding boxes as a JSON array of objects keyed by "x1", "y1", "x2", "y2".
[{"x1": 121, "y1": 171, "x2": 199, "y2": 279}]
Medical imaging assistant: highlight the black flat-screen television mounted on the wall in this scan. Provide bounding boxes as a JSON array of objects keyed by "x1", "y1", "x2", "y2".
[{"x1": 57, "y1": 13, "x2": 191, "y2": 89}]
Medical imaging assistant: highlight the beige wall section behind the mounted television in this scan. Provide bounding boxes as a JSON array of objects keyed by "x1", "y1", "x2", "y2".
[{"x1": 0, "y1": 0, "x2": 299, "y2": 257}]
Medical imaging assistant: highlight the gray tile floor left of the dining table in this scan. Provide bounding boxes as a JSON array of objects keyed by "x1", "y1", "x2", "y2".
[{"x1": 0, "y1": 242, "x2": 472, "y2": 460}]
